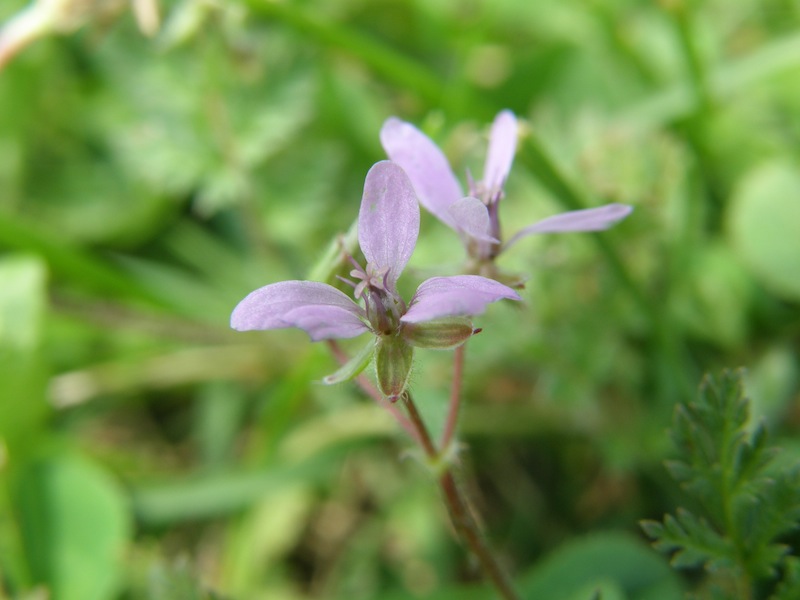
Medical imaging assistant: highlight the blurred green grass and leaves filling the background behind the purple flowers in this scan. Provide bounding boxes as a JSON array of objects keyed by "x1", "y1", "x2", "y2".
[{"x1": 0, "y1": 0, "x2": 800, "y2": 600}]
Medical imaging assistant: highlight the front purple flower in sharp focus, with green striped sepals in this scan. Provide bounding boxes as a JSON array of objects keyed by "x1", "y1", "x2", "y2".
[{"x1": 231, "y1": 161, "x2": 520, "y2": 400}]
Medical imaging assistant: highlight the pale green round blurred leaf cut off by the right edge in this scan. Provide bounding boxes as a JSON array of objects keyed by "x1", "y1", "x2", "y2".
[{"x1": 728, "y1": 162, "x2": 800, "y2": 300}]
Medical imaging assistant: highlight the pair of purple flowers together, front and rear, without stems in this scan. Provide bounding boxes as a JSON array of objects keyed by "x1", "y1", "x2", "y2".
[{"x1": 231, "y1": 111, "x2": 631, "y2": 400}]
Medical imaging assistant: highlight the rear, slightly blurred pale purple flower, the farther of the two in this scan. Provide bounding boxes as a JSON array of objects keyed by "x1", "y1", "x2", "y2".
[{"x1": 380, "y1": 110, "x2": 633, "y2": 273}]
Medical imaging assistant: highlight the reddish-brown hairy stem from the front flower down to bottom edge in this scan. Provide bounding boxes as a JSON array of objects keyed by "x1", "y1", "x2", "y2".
[{"x1": 403, "y1": 394, "x2": 520, "y2": 600}]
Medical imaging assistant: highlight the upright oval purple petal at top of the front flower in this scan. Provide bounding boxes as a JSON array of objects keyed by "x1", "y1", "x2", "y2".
[{"x1": 358, "y1": 160, "x2": 419, "y2": 285}]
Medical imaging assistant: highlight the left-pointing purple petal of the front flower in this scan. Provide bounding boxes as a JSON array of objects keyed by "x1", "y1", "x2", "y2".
[{"x1": 231, "y1": 281, "x2": 368, "y2": 341}]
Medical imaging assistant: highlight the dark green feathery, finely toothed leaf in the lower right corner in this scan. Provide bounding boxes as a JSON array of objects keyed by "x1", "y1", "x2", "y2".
[{"x1": 643, "y1": 371, "x2": 800, "y2": 598}]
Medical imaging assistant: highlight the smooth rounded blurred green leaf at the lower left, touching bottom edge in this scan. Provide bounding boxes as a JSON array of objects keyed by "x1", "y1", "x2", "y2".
[{"x1": 15, "y1": 455, "x2": 130, "y2": 600}]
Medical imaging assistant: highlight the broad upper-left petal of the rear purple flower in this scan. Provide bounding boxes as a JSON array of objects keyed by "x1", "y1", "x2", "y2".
[{"x1": 381, "y1": 117, "x2": 464, "y2": 229}]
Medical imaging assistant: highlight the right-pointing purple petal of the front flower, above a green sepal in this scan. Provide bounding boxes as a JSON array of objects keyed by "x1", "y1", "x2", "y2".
[{"x1": 400, "y1": 275, "x2": 521, "y2": 323}]
